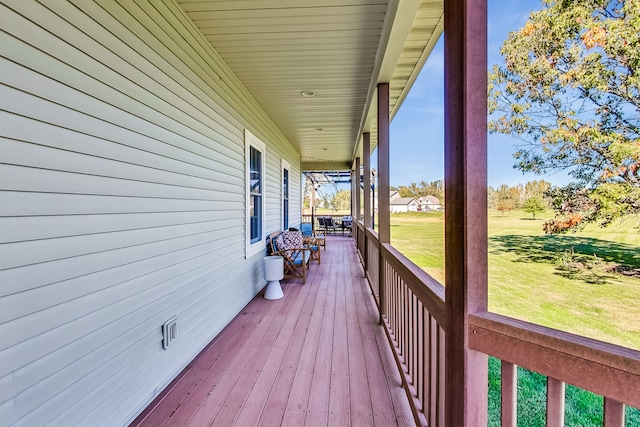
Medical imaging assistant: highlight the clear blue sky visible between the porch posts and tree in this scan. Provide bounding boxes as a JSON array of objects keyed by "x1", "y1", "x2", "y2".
[{"x1": 384, "y1": 0, "x2": 568, "y2": 187}]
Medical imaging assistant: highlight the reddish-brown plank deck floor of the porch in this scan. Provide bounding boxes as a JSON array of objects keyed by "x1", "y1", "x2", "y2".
[{"x1": 132, "y1": 236, "x2": 414, "y2": 427}]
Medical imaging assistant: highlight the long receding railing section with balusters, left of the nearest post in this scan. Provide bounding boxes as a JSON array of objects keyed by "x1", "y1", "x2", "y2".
[{"x1": 356, "y1": 223, "x2": 446, "y2": 426}]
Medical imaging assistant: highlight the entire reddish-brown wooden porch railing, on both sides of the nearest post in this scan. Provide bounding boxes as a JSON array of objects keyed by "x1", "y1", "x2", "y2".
[{"x1": 354, "y1": 222, "x2": 640, "y2": 427}]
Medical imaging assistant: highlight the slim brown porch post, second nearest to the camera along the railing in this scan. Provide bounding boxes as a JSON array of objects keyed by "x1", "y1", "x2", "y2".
[{"x1": 378, "y1": 83, "x2": 391, "y2": 324}]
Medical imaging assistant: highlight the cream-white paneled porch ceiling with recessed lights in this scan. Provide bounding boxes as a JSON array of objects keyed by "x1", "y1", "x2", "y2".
[{"x1": 178, "y1": 0, "x2": 444, "y2": 170}]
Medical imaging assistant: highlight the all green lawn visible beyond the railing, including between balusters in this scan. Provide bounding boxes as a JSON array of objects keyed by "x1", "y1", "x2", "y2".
[{"x1": 391, "y1": 211, "x2": 640, "y2": 426}]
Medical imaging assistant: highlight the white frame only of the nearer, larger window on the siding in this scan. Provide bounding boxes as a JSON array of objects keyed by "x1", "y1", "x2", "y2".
[{"x1": 244, "y1": 129, "x2": 267, "y2": 258}]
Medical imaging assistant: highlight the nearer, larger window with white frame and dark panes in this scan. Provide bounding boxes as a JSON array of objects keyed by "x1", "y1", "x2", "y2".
[{"x1": 244, "y1": 130, "x2": 266, "y2": 258}]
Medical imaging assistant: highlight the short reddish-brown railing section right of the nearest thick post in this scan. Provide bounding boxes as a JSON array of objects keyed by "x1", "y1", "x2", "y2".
[{"x1": 469, "y1": 313, "x2": 640, "y2": 426}]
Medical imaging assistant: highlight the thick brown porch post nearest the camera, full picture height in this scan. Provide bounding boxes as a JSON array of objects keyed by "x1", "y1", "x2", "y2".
[{"x1": 444, "y1": 0, "x2": 487, "y2": 426}]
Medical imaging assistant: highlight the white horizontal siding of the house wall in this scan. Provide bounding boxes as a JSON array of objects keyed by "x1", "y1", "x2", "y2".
[{"x1": 0, "y1": 0, "x2": 301, "y2": 426}]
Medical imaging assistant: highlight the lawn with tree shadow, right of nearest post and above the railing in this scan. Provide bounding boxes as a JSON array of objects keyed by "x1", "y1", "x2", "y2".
[{"x1": 489, "y1": 212, "x2": 640, "y2": 349}]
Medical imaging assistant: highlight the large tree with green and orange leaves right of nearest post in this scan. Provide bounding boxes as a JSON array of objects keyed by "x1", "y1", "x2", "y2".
[{"x1": 489, "y1": 0, "x2": 640, "y2": 231}]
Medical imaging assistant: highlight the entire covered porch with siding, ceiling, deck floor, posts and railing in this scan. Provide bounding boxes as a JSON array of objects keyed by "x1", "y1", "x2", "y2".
[{"x1": 0, "y1": 0, "x2": 640, "y2": 426}]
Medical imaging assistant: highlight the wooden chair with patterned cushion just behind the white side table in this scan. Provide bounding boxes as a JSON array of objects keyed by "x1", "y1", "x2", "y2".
[{"x1": 268, "y1": 231, "x2": 311, "y2": 284}]
